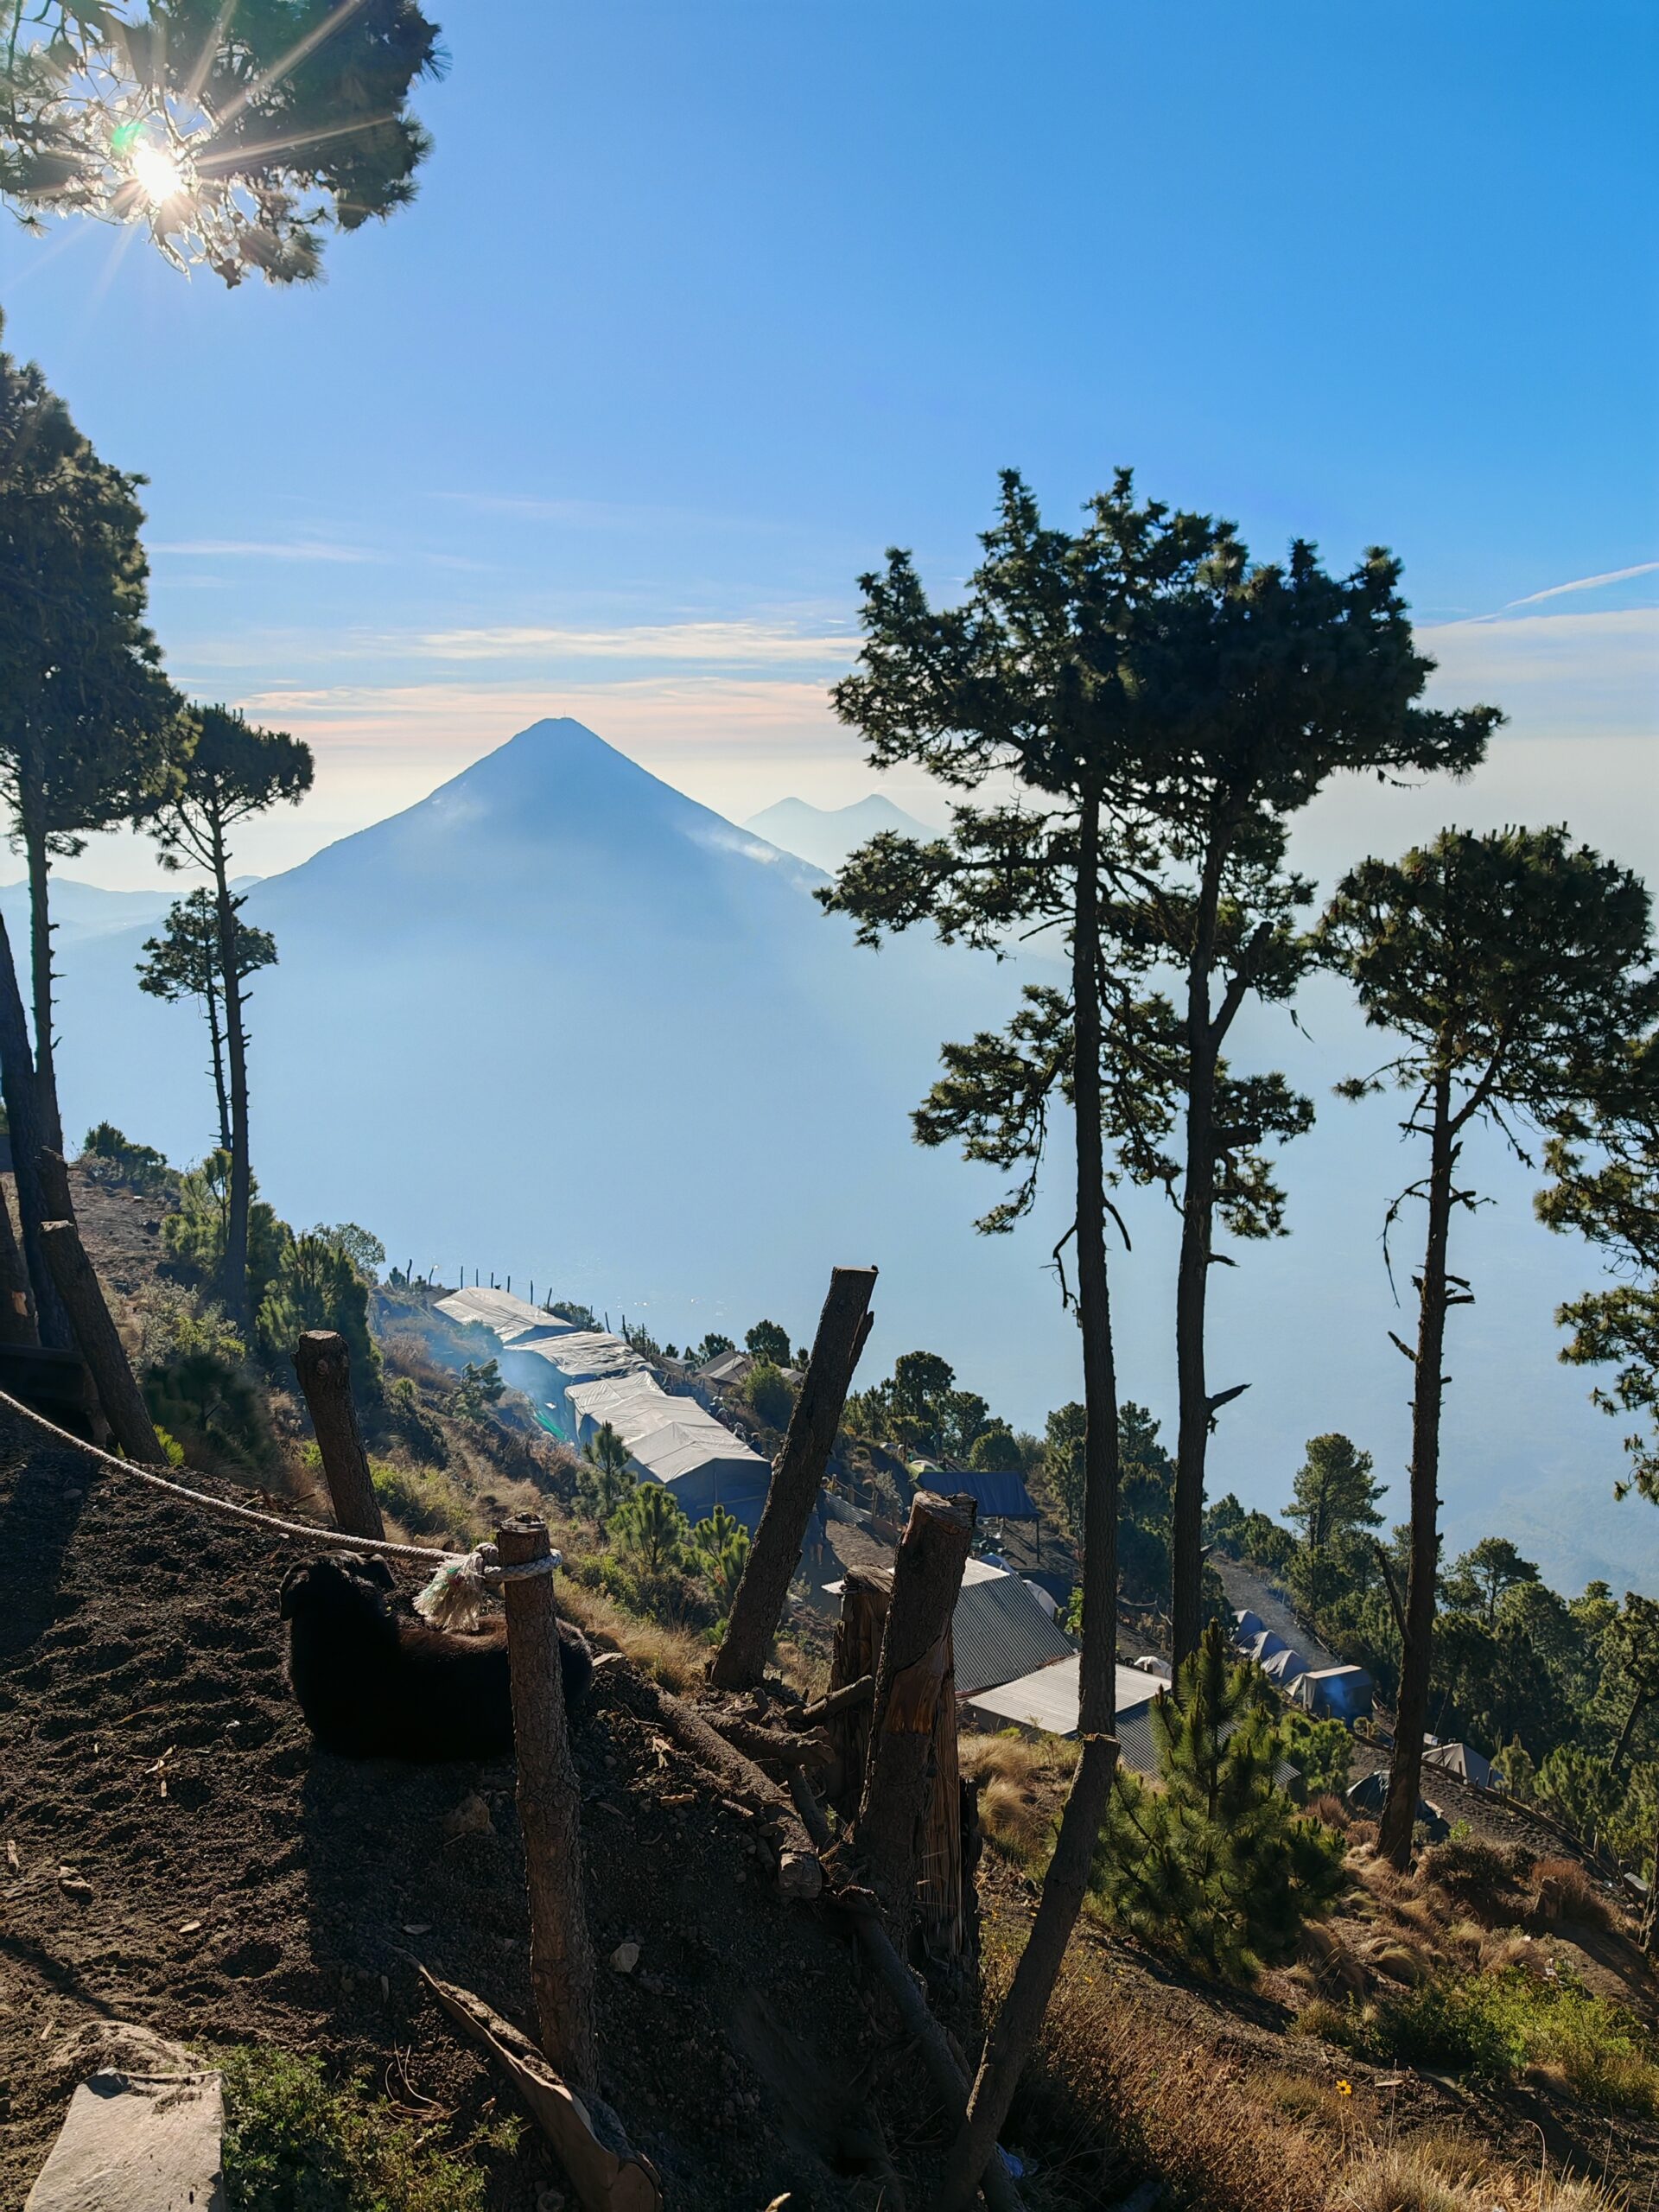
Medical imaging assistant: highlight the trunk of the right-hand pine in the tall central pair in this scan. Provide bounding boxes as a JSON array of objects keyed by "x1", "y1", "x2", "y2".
[{"x1": 1170, "y1": 836, "x2": 1224, "y2": 1672}]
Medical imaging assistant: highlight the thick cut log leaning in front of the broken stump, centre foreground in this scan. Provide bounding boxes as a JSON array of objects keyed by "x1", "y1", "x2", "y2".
[{"x1": 854, "y1": 1491, "x2": 973, "y2": 1931}]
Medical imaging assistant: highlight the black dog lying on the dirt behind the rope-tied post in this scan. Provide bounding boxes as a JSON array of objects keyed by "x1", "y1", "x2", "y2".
[{"x1": 281, "y1": 1553, "x2": 593, "y2": 1761}]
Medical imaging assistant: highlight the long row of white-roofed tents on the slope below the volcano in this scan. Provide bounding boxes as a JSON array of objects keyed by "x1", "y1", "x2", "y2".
[{"x1": 438, "y1": 1287, "x2": 772, "y2": 1531}]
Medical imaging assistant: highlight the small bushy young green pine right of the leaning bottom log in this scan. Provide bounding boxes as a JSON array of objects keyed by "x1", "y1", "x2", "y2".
[{"x1": 1095, "y1": 1621, "x2": 1344, "y2": 1980}]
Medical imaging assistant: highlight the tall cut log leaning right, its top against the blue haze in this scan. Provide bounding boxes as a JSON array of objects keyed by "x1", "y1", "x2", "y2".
[{"x1": 708, "y1": 1268, "x2": 876, "y2": 1690}]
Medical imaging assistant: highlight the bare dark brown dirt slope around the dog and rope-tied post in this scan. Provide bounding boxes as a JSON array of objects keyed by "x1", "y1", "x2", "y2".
[{"x1": 0, "y1": 1418, "x2": 929, "y2": 2212}]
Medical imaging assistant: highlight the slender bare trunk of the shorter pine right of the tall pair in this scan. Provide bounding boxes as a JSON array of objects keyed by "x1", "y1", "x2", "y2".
[{"x1": 1378, "y1": 1075, "x2": 1458, "y2": 1872}]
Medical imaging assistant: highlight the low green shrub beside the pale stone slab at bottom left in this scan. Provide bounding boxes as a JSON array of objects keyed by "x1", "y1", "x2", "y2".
[{"x1": 214, "y1": 2044, "x2": 518, "y2": 2212}]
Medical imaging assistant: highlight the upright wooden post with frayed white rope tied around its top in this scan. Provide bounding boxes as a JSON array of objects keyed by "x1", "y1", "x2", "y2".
[{"x1": 495, "y1": 1516, "x2": 600, "y2": 2094}]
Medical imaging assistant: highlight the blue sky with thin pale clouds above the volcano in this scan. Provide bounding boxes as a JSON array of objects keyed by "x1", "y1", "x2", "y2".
[{"x1": 0, "y1": 0, "x2": 1659, "y2": 882}]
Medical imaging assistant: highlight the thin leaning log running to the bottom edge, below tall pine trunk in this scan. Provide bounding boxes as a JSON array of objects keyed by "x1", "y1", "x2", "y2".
[{"x1": 931, "y1": 1737, "x2": 1117, "y2": 2212}]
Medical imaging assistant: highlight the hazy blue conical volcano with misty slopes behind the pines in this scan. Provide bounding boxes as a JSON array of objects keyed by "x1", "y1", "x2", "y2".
[{"x1": 41, "y1": 721, "x2": 1659, "y2": 1595}]
